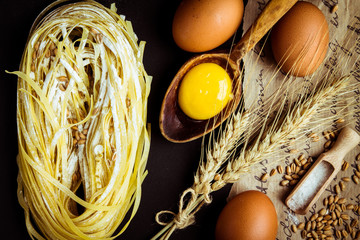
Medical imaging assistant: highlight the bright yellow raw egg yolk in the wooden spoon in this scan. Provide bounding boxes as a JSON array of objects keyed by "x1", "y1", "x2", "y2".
[{"x1": 178, "y1": 63, "x2": 233, "y2": 120}]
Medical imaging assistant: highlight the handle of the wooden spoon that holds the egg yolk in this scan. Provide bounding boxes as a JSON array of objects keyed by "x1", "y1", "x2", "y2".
[{"x1": 230, "y1": 0, "x2": 297, "y2": 66}]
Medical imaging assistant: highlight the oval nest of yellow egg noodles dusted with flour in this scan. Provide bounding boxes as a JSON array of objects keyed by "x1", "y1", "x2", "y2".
[{"x1": 14, "y1": 1, "x2": 151, "y2": 239}]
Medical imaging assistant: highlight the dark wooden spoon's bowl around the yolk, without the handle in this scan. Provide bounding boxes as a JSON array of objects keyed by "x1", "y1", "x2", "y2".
[{"x1": 159, "y1": 52, "x2": 242, "y2": 143}]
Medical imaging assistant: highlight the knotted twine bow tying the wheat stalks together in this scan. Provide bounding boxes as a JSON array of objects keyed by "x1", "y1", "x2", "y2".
[{"x1": 156, "y1": 188, "x2": 199, "y2": 229}]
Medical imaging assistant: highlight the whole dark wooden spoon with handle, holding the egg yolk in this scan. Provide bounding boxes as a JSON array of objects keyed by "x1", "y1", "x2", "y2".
[{"x1": 159, "y1": 0, "x2": 297, "y2": 142}]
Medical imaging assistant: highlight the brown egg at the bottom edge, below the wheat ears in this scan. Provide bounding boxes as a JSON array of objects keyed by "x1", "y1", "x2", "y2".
[{"x1": 215, "y1": 190, "x2": 278, "y2": 240}]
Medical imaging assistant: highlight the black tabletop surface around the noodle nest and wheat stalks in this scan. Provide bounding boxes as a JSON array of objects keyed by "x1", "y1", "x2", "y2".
[{"x1": 0, "y1": 0, "x2": 239, "y2": 240}]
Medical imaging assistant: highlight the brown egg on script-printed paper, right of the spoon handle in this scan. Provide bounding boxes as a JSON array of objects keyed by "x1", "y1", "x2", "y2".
[{"x1": 271, "y1": 2, "x2": 329, "y2": 77}]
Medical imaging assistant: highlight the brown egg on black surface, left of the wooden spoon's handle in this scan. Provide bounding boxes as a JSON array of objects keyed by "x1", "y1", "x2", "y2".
[{"x1": 172, "y1": 0, "x2": 244, "y2": 52}]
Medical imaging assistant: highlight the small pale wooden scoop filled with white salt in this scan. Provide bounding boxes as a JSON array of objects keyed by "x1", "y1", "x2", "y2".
[{"x1": 285, "y1": 127, "x2": 360, "y2": 215}]
